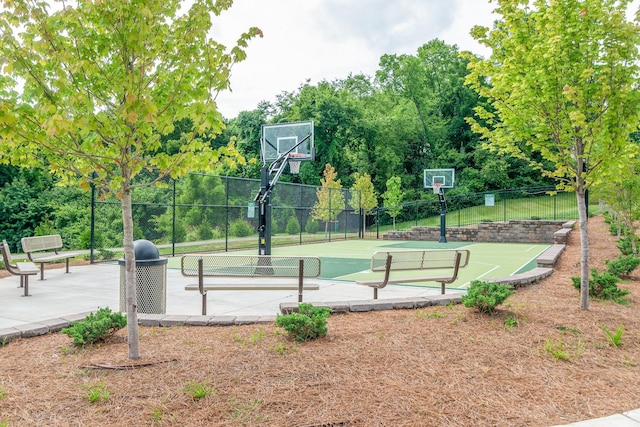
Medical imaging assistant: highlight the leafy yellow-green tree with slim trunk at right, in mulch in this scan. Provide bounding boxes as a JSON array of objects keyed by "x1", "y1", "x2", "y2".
[{"x1": 467, "y1": 0, "x2": 640, "y2": 310}]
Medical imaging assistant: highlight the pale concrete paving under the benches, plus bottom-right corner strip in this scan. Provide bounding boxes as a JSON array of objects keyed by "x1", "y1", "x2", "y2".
[{"x1": 0, "y1": 264, "x2": 640, "y2": 427}]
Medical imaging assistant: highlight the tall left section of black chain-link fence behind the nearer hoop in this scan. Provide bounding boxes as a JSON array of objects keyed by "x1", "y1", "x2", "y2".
[{"x1": 91, "y1": 174, "x2": 363, "y2": 261}]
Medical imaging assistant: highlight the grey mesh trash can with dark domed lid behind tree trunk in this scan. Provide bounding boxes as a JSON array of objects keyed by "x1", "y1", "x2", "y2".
[{"x1": 118, "y1": 240, "x2": 169, "y2": 314}]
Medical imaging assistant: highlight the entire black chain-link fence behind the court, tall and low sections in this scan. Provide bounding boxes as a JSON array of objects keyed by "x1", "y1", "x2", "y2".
[{"x1": 91, "y1": 174, "x2": 578, "y2": 261}]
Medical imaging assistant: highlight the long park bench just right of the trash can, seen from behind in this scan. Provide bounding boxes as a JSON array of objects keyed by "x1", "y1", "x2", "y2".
[{"x1": 180, "y1": 254, "x2": 320, "y2": 315}]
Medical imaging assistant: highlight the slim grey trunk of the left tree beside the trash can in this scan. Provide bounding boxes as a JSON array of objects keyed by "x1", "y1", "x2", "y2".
[{"x1": 121, "y1": 189, "x2": 140, "y2": 359}]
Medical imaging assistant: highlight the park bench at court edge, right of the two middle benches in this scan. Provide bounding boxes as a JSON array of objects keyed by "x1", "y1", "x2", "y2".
[{"x1": 356, "y1": 249, "x2": 469, "y2": 299}]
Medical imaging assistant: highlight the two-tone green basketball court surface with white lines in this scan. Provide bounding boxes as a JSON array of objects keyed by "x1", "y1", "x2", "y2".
[{"x1": 162, "y1": 240, "x2": 550, "y2": 288}]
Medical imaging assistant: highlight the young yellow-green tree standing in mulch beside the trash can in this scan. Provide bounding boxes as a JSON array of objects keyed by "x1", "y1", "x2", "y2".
[{"x1": 0, "y1": 0, "x2": 261, "y2": 359}]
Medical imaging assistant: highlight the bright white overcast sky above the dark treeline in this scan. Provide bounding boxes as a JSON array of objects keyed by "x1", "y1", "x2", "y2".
[{"x1": 214, "y1": 0, "x2": 640, "y2": 118}]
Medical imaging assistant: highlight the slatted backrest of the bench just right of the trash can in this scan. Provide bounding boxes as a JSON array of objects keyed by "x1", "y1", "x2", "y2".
[{"x1": 180, "y1": 254, "x2": 320, "y2": 278}]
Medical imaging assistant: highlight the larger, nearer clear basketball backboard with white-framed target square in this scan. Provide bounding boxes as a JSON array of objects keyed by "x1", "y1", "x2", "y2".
[{"x1": 260, "y1": 121, "x2": 315, "y2": 163}]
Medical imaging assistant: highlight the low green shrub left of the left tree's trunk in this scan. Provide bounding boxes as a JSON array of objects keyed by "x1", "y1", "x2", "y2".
[{"x1": 61, "y1": 307, "x2": 127, "y2": 346}]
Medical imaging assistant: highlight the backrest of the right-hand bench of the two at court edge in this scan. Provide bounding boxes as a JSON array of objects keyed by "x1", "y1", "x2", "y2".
[{"x1": 371, "y1": 249, "x2": 469, "y2": 271}]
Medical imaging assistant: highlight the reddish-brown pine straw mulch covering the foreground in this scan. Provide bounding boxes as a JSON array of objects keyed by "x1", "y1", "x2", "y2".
[{"x1": 0, "y1": 218, "x2": 640, "y2": 426}]
